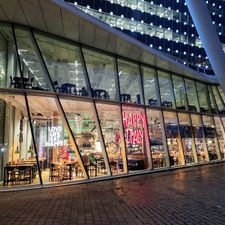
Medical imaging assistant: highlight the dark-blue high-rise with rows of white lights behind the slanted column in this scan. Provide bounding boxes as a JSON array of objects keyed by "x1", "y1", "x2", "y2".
[{"x1": 65, "y1": 0, "x2": 225, "y2": 75}]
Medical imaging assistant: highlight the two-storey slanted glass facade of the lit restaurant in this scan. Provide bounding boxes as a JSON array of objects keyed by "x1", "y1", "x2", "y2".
[{"x1": 0, "y1": 24, "x2": 225, "y2": 189}]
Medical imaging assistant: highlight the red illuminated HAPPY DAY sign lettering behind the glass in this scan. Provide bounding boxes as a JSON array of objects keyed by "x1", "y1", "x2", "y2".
[{"x1": 123, "y1": 112, "x2": 146, "y2": 144}]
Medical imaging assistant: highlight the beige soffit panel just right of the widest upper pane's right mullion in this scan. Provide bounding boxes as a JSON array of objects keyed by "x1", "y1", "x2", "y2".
[{"x1": 80, "y1": 20, "x2": 96, "y2": 47}]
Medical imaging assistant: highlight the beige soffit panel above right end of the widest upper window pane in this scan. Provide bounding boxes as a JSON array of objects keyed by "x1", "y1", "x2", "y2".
[{"x1": 62, "y1": 9, "x2": 80, "y2": 41}]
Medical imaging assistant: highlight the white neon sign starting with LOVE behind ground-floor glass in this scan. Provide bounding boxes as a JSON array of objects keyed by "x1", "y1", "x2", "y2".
[{"x1": 47, "y1": 127, "x2": 63, "y2": 146}]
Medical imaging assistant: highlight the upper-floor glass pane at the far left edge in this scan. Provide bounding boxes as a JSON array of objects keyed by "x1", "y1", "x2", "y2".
[{"x1": 0, "y1": 24, "x2": 22, "y2": 88}]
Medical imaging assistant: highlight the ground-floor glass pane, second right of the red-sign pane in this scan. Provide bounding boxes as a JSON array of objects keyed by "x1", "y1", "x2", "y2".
[{"x1": 163, "y1": 111, "x2": 184, "y2": 166}]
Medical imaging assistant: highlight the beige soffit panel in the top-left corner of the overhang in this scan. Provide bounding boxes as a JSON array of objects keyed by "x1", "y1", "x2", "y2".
[{"x1": 0, "y1": 0, "x2": 28, "y2": 25}]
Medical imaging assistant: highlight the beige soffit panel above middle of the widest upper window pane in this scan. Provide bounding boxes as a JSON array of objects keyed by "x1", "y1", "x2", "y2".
[{"x1": 39, "y1": 0, "x2": 64, "y2": 37}]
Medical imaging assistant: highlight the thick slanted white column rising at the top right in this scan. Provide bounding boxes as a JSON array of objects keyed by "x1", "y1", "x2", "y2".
[{"x1": 186, "y1": 0, "x2": 225, "y2": 92}]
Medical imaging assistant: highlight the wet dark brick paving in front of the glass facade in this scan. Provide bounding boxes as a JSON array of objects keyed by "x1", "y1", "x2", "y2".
[{"x1": 0, "y1": 163, "x2": 225, "y2": 225}]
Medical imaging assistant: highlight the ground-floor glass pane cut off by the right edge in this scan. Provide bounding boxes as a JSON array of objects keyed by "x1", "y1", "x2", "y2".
[{"x1": 214, "y1": 116, "x2": 225, "y2": 159}]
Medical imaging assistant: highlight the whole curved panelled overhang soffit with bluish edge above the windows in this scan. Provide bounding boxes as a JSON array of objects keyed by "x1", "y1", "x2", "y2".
[{"x1": 0, "y1": 0, "x2": 218, "y2": 84}]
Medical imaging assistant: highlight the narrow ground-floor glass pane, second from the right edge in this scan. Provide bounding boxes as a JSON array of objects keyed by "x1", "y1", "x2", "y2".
[{"x1": 202, "y1": 116, "x2": 219, "y2": 160}]
